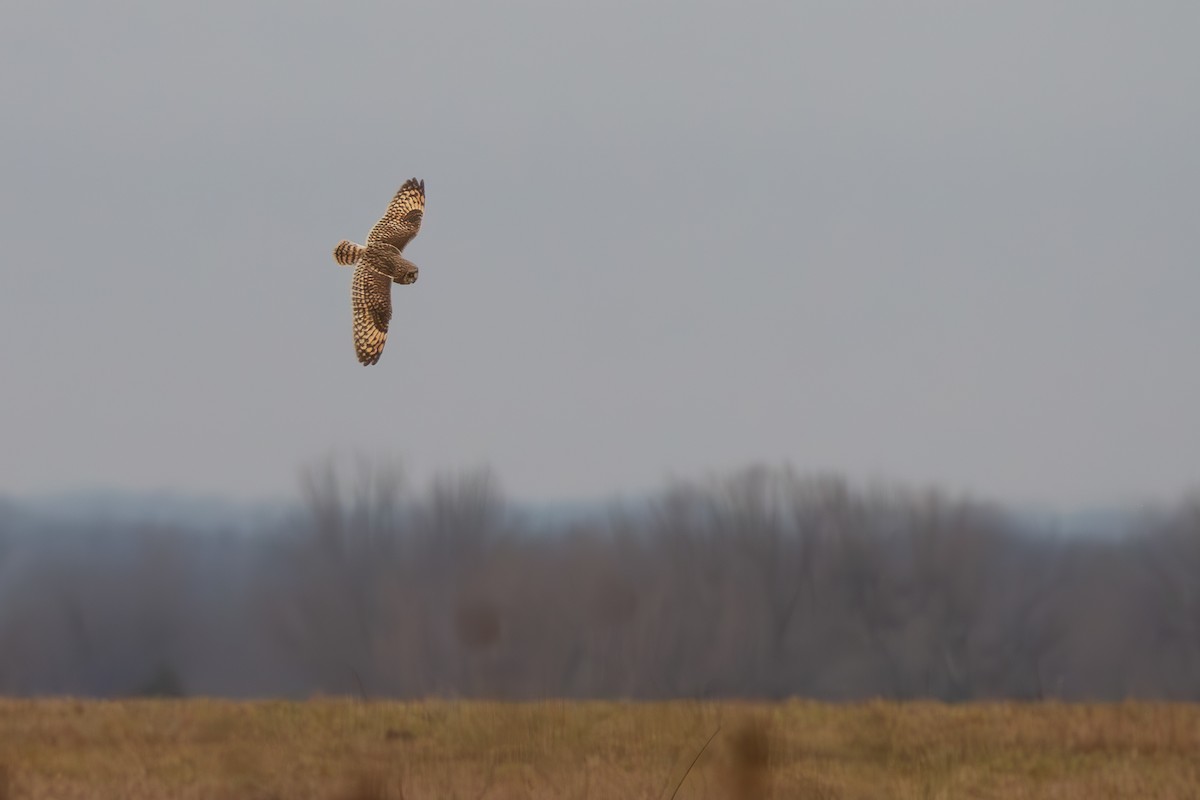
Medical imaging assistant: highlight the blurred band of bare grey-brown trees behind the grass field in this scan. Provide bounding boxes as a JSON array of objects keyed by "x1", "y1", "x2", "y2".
[{"x1": 0, "y1": 468, "x2": 1200, "y2": 700}]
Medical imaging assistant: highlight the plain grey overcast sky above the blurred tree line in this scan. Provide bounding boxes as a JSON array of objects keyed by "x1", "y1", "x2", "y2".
[{"x1": 0, "y1": 0, "x2": 1200, "y2": 506}]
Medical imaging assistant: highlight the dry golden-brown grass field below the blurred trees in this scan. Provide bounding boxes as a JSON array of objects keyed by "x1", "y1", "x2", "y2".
[{"x1": 0, "y1": 699, "x2": 1200, "y2": 800}]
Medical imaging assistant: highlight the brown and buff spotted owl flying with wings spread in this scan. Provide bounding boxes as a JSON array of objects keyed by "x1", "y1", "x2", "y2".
[{"x1": 334, "y1": 178, "x2": 425, "y2": 365}]
